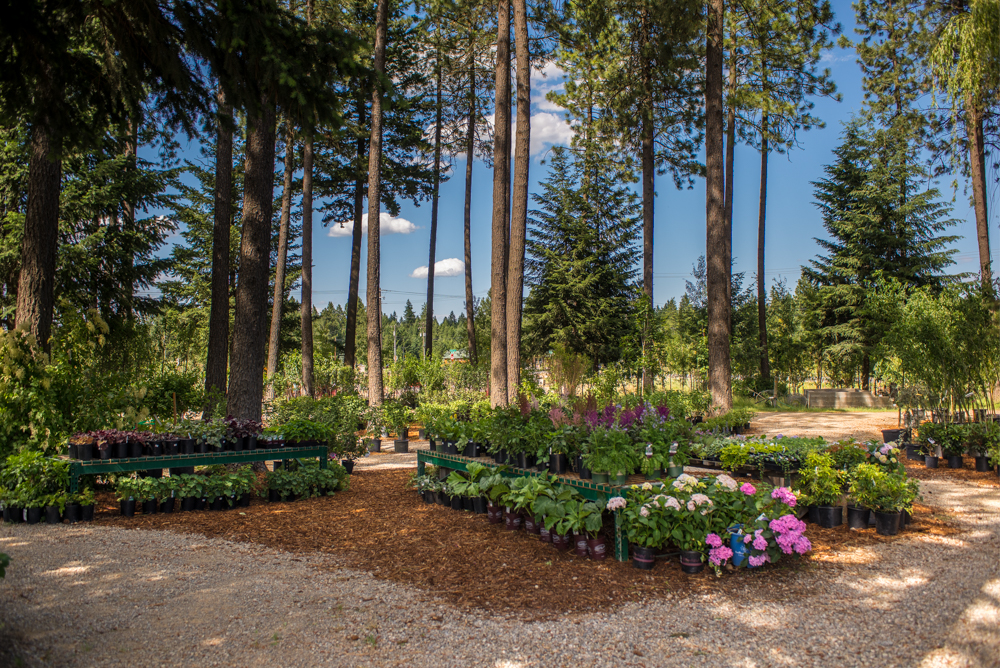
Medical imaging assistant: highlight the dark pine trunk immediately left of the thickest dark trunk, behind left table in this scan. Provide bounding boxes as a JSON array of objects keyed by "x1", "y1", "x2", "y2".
[{"x1": 205, "y1": 91, "x2": 233, "y2": 410}]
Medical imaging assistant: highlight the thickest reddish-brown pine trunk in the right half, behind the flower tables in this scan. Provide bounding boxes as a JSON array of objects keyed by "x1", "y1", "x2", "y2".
[{"x1": 705, "y1": 0, "x2": 732, "y2": 411}]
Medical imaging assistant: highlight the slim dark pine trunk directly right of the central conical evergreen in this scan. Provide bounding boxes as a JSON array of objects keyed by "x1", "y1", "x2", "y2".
[{"x1": 642, "y1": 16, "x2": 656, "y2": 394}]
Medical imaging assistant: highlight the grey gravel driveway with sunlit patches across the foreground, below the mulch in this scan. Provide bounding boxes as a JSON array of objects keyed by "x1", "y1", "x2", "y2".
[{"x1": 0, "y1": 472, "x2": 1000, "y2": 668}]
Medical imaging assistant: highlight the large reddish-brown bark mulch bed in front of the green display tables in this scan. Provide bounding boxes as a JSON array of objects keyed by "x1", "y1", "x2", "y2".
[{"x1": 95, "y1": 470, "x2": 955, "y2": 618}]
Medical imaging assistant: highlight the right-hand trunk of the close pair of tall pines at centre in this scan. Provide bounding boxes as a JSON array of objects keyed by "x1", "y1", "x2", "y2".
[{"x1": 507, "y1": 0, "x2": 531, "y2": 401}]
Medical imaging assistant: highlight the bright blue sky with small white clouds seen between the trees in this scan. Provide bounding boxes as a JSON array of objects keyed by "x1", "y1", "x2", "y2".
[{"x1": 146, "y1": 0, "x2": 998, "y2": 318}]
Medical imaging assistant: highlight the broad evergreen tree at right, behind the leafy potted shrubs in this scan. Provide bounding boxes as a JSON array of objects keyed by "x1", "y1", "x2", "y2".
[{"x1": 804, "y1": 120, "x2": 957, "y2": 389}]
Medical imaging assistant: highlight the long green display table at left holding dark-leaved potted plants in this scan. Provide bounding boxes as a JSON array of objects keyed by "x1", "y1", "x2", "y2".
[{"x1": 69, "y1": 445, "x2": 327, "y2": 493}]
